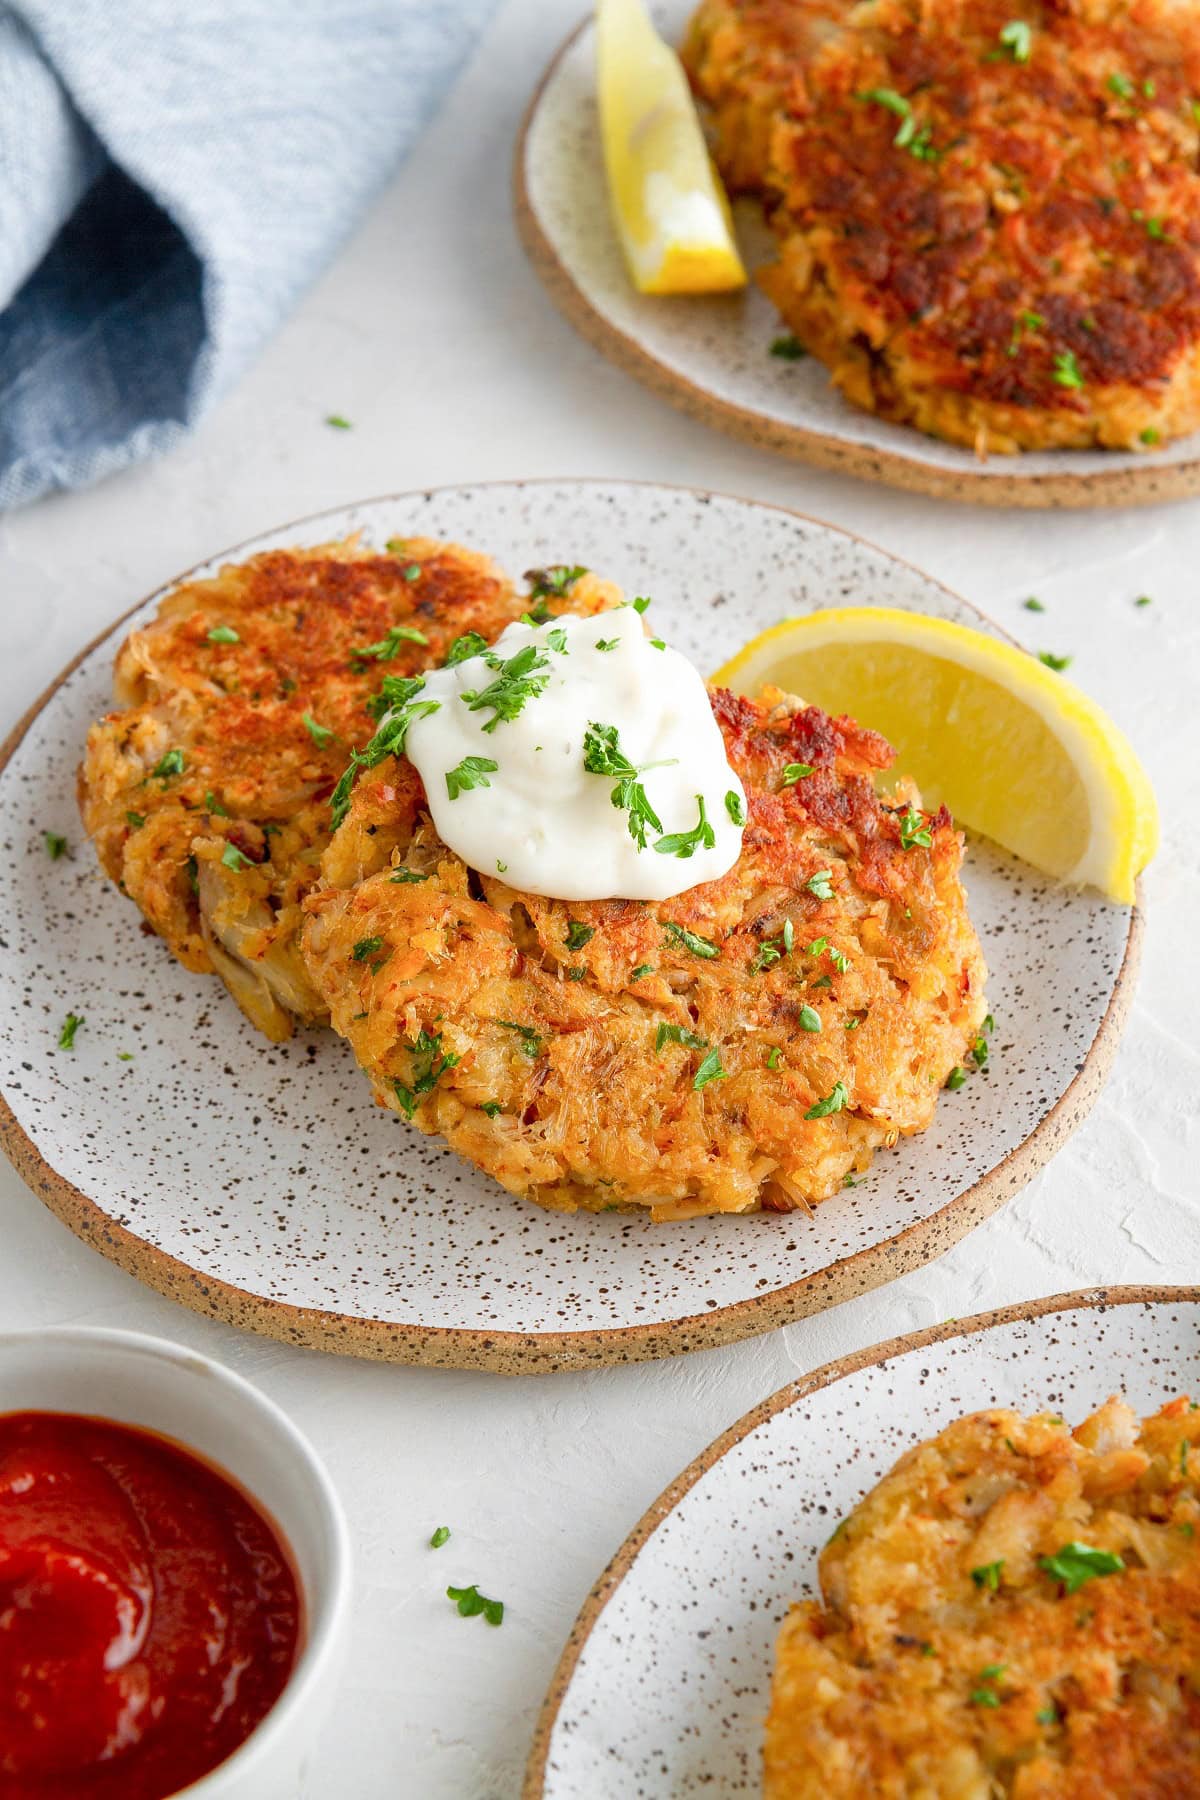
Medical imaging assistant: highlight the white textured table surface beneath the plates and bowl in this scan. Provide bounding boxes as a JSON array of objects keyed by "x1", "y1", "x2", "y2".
[{"x1": 0, "y1": 0, "x2": 1200, "y2": 1800}]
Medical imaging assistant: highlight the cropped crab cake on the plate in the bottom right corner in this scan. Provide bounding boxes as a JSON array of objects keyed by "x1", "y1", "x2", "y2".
[{"x1": 763, "y1": 1399, "x2": 1200, "y2": 1800}]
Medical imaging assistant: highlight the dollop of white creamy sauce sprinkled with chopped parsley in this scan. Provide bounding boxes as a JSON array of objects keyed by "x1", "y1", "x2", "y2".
[{"x1": 405, "y1": 607, "x2": 745, "y2": 900}]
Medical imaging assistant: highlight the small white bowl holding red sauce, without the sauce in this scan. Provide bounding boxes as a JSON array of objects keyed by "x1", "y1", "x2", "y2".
[{"x1": 0, "y1": 1327, "x2": 351, "y2": 1800}]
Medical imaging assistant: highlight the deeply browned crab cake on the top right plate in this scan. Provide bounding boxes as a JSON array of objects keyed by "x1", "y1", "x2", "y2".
[{"x1": 685, "y1": 0, "x2": 1200, "y2": 454}]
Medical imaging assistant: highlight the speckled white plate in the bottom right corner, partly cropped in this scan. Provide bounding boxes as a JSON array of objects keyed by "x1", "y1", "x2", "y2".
[{"x1": 524, "y1": 1287, "x2": 1200, "y2": 1800}]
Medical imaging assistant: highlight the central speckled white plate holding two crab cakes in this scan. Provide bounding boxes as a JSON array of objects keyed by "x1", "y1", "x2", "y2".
[{"x1": 0, "y1": 482, "x2": 1139, "y2": 1372}]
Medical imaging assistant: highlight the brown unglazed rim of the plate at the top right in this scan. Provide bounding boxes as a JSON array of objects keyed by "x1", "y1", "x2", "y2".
[{"x1": 511, "y1": 14, "x2": 1200, "y2": 511}]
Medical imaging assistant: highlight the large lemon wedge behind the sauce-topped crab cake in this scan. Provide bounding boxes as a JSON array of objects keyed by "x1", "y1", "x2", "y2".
[{"x1": 712, "y1": 607, "x2": 1159, "y2": 902}]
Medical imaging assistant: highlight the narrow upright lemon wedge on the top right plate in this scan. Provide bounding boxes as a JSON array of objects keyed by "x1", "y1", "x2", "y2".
[{"x1": 596, "y1": 0, "x2": 747, "y2": 293}]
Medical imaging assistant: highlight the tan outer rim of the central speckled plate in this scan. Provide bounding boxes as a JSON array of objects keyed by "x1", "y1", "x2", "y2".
[{"x1": 0, "y1": 475, "x2": 1144, "y2": 1375}]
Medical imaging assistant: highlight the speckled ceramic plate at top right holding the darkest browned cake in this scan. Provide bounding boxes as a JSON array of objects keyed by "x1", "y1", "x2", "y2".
[{"x1": 515, "y1": 0, "x2": 1200, "y2": 506}]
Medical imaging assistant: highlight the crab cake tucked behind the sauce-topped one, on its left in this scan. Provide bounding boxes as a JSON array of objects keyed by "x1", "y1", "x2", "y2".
[{"x1": 79, "y1": 538, "x2": 529, "y2": 1040}]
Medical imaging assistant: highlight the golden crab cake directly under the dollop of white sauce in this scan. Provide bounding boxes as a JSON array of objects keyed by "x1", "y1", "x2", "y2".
[{"x1": 304, "y1": 689, "x2": 984, "y2": 1219}]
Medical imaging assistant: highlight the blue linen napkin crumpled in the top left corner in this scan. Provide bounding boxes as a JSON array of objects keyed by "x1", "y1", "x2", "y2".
[{"x1": 0, "y1": 0, "x2": 493, "y2": 508}]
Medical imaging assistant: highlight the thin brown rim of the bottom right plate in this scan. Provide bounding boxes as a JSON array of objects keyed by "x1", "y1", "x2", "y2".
[{"x1": 522, "y1": 1282, "x2": 1200, "y2": 1800}]
